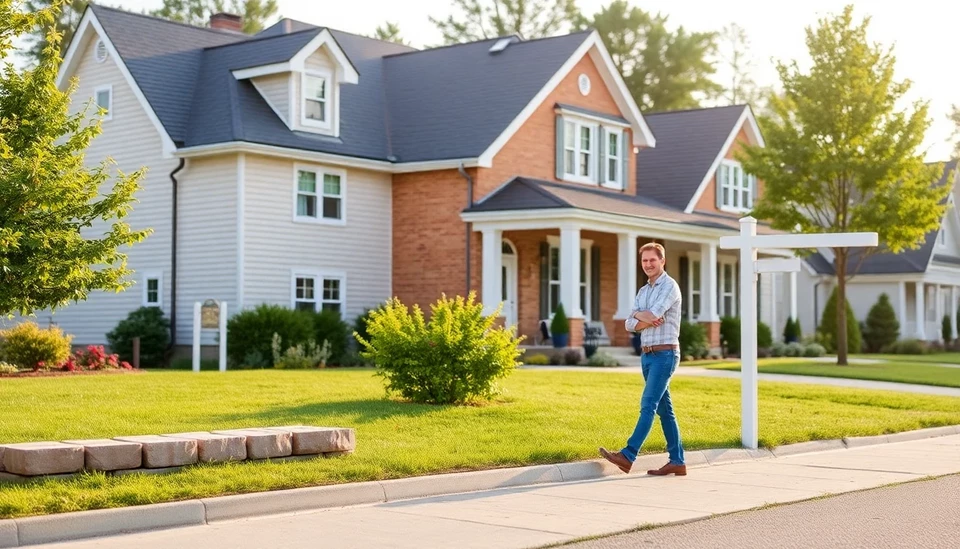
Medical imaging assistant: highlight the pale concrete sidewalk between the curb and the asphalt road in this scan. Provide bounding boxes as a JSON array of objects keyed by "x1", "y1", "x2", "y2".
[{"x1": 28, "y1": 434, "x2": 960, "y2": 549}]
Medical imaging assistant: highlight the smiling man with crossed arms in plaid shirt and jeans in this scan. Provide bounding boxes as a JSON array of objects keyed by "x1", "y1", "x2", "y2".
[{"x1": 600, "y1": 242, "x2": 687, "y2": 475}]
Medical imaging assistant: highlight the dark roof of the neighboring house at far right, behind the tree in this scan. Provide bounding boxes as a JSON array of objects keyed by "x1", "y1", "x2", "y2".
[{"x1": 805, "y1": 160, "x2": 960, "y2": 275}]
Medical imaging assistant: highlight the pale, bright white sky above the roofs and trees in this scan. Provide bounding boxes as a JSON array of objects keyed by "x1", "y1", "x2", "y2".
[{"x1": 9, "y1": 0, "x2": 960, "y2": 161}]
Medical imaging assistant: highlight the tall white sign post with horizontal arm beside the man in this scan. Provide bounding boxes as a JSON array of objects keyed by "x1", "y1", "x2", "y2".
[{"x1": 720, "y1": 217, "x2": 878, "y2": 450}]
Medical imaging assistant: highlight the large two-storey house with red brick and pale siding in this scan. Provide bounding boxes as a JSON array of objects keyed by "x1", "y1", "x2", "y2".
[{"x1": 16, "y1": 5, "x2": 796, "y2": 356}]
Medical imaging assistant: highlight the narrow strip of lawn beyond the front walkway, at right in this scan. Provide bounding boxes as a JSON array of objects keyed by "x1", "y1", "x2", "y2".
[{"x1": 708, "y1": 358, "x2": 960, "y2": 387}]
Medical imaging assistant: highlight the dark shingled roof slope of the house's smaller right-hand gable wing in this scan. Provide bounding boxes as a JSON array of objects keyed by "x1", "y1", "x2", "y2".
[{"x1": 637, "y1": 105, "x2": 749, "y2": 210}]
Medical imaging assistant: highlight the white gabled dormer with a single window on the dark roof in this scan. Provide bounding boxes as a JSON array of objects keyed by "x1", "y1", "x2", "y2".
[{"x1": 233, "y1": 29, "x2": 360, "y2": 137}]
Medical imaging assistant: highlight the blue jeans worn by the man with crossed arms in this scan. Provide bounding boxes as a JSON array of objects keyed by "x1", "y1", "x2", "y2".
[{"x1": 621, "y1": 350, "x2": 683, "y2": 465}]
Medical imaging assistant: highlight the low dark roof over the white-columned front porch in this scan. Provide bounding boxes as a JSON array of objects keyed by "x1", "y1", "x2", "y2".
[{"x1": 464, "y1": 177, "x2": 782, "y2": 234}]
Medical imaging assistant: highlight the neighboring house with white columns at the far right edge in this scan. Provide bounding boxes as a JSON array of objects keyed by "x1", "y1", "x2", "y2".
[{"x1": 796, "y1": 160, "x2": 960, "y2": 341}]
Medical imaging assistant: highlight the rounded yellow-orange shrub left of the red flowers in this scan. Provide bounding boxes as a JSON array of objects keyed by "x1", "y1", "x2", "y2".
[{"x1": 0, "y1": 322, "x2": 73, "y2": 370}]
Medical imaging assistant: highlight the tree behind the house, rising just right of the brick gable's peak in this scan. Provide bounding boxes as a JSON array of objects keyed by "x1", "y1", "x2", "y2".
[{"x1": 576, "y1": 0, "x2": 722, "y2": 111}]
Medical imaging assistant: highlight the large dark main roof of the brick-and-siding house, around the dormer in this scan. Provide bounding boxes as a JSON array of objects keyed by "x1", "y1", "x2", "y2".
[{"x1": 90, "y1": 4, "x2": 589, "y2": 162}]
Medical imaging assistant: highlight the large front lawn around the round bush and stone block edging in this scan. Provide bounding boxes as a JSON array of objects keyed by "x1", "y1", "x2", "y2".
[{"x1": 0, "y1": 370, "x2": 960, "y2": 518}]
